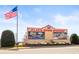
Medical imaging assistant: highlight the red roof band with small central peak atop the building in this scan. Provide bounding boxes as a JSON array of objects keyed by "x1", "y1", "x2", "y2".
[{"x1": 27, "y1": 25, "x2": 67, "y2": 32}]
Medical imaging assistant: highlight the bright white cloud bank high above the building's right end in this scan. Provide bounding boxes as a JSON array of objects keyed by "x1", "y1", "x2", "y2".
[{"x1": 54, "y1": 12, "x2": 79, "y2": 25}]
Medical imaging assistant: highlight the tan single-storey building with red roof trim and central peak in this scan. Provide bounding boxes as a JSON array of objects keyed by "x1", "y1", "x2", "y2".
[{"x1": 24, "y1": 25, "x2": 70, "y2": 44}]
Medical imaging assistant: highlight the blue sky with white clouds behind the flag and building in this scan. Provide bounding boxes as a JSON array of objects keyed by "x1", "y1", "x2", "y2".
[{"x1": 0, "y1": 5, "x2": 79, "y2": 41}]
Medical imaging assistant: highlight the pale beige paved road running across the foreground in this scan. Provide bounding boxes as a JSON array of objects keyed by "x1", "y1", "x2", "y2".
[{"x1": 0, "y1": 45, "x2": 79, "y2": 54}]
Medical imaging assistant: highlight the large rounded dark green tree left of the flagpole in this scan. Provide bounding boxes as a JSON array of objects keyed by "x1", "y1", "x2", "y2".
[{"x1": 1, "y1": 30, "x2": 15, "y2": 47}]
